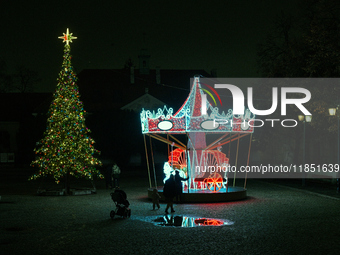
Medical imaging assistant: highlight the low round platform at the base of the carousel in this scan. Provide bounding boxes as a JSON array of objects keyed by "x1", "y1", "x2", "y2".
[{"x1": 148, "y1": 187, "x2": 247, "y2": 203}]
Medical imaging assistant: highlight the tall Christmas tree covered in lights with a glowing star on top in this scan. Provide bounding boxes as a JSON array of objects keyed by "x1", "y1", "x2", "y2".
[{"x1": 30, "y1": 29, "x2": 103, "y2": 192}]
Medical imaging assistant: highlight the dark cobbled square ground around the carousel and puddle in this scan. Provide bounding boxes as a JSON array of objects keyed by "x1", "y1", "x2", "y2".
[{"x1": 0, "y1": 166, "x2": 340, "y2": 254}]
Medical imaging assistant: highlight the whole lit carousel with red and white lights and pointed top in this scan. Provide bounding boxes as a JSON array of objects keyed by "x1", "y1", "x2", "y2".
[{"x1": 140, "y1": 77, "x2": 255, "y2": 202}]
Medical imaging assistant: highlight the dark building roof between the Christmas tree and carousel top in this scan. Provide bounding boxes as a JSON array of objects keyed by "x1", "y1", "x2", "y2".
[{"x1": 78, "y1": 69, "x2": 211, "y2": 112}]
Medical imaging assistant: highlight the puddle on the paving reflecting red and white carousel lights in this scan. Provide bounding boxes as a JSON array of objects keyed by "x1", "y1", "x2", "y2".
[{"x1": 151, "y1": 215, "x2": 234, "y2": 228}]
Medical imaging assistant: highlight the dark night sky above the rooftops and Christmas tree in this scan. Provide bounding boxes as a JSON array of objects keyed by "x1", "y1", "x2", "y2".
[{"x1": 0, "y1": 0, "x2": 297, "y2": 92}]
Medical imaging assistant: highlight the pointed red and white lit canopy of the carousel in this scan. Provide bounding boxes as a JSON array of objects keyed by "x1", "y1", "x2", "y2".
[{"x1": 140, "y1": 77, "x2": 255, "y2": 134}]
